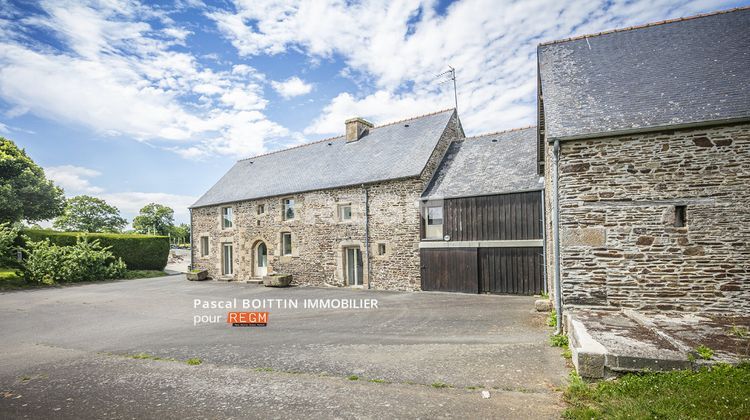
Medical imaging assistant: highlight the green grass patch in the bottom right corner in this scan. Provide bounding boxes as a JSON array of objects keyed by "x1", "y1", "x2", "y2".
[{"x1": 564, "y1": 363, "x2": 750, "y2": 419}]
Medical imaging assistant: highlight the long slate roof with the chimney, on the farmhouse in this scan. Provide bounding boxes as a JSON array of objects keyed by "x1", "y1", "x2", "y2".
[{"x1": 191, "y1": 109, "x2": 454, "y2": 208}]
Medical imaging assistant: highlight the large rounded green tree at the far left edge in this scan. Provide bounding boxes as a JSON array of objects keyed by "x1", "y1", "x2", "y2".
[{"x1": 0, "y1": 137, "x2": 65, "y2": 222}]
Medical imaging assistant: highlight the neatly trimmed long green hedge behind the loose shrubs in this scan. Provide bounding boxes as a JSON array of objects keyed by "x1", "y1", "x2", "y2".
[{"x1": 21, "y1": 229, "x2": 169, "y2": 270}]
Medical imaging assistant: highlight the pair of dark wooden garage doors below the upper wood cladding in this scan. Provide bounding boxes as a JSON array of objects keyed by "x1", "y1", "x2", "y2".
[{"x1": 421, "y1": 247, "x2": 544, "y2": 295}]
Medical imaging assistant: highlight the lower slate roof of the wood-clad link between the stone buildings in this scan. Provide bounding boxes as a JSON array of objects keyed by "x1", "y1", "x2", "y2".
[{"x1": 422, "y1": 127, "x2": 544, "y2": 199}]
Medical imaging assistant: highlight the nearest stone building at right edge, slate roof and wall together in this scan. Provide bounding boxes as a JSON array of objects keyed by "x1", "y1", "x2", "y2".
[{"x1": 538, "y1": 9, "x2": 750, "y2": 314}]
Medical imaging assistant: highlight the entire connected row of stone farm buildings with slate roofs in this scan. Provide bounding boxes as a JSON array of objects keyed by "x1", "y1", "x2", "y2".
[{"x1": 191, "y1": 8, "x2": 750, "y2": 314}]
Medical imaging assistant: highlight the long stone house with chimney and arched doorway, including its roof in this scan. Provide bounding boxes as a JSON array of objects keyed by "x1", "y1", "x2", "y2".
[{"x1": 191, "y1": 110, "x2": 464, "y2": 290}]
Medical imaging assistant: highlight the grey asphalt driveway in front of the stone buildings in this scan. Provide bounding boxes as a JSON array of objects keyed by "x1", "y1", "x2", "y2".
[{"x1": 0, "y1": 275, "x2": 568, "y2": 418}]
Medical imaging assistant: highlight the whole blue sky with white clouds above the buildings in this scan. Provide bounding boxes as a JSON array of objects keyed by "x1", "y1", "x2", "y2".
[{"x1": 0, "y1": 0, "x2": 750, "y2": 226}]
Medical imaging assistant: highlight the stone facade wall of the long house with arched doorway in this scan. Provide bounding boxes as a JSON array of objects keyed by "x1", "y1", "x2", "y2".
[{"x1": 192, "y1": 110, "x2": 463, "y2": 290}]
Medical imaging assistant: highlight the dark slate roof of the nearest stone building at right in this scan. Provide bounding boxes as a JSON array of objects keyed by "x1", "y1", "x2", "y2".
[{"x1": 538, "y1": 8, "x2": 750, "y2": 139}]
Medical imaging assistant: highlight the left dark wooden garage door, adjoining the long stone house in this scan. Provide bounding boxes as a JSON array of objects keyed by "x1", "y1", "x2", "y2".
[{"x1": 421, "y1": 248, "x2": 479, "y2": 293}]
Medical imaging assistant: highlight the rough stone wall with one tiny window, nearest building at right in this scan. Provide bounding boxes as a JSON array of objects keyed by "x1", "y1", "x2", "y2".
[{"x1": 547, "y1": 124, "x2": 750, "y2": 314}]
